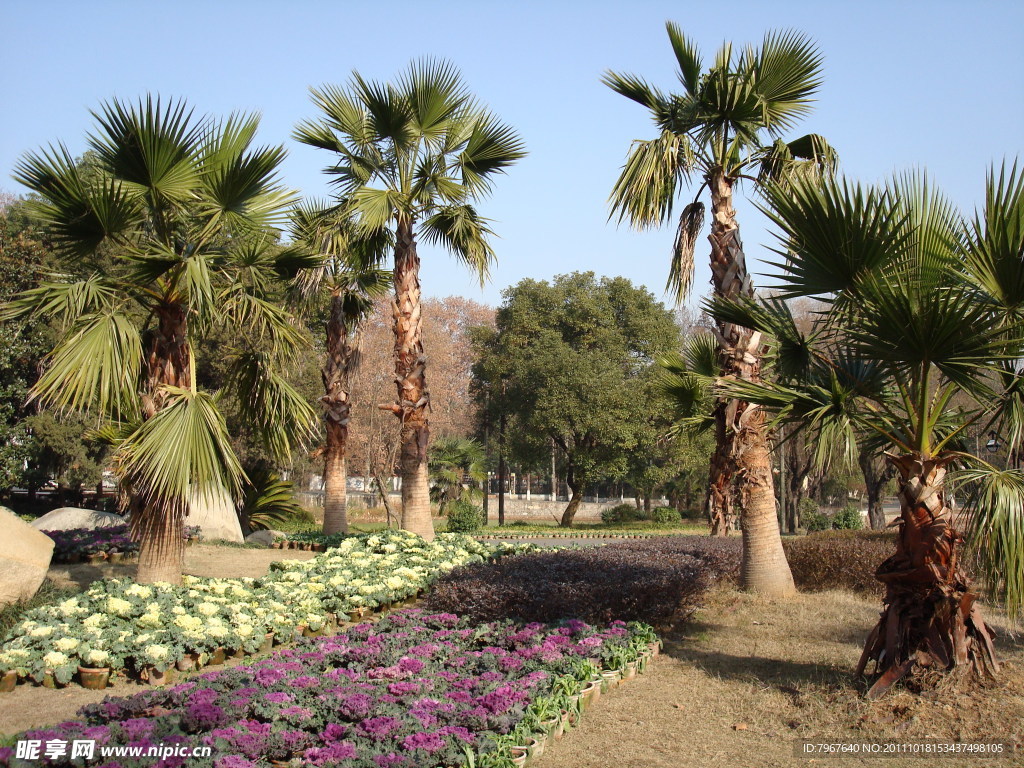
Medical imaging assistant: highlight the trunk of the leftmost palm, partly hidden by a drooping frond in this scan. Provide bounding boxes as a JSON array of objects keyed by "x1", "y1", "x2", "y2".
[{"x1": 133, "y1": 304, "x2": 193, "y2": 584}]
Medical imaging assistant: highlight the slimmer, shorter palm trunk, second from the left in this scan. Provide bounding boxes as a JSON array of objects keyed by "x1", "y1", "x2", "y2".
[{"x1": 321, "y1": 292, "x2": 353, "y2": 535}]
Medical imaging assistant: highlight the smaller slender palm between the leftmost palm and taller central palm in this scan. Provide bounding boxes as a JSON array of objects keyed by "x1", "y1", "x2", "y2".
[{"x1": 292, "y1": 207, "x2": 391, "y2": 535}]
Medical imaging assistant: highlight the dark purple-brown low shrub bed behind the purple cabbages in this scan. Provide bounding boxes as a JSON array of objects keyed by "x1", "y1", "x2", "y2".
[{"x1": 426, "y1": 537, "x2": 739, "y2": 625}]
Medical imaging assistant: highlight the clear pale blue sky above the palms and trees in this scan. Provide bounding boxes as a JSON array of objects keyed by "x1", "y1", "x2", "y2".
[{"x1": 0, "y1": 0, "x2": 1024, "y2": 311}]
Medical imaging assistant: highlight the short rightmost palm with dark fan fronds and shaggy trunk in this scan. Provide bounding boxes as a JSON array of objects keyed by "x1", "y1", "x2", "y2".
[{"x1": 714, "y1": 168, "x2": 1024, "y2": 698}]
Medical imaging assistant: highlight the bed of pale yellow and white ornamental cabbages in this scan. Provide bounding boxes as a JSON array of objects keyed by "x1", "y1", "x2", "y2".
[{"x1": 0, "y1": 531, "x2": 531, "y2": 684}]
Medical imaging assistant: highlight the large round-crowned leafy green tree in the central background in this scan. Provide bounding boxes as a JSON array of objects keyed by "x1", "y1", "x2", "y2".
[{"x1": 474, "y1": 272, "x2": 679, "y2": 526}]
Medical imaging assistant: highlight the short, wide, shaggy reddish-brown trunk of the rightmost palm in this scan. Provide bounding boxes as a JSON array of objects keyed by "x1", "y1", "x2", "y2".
[{"x1": 857, "y1": 454, "x2": 998, "y2": 698}]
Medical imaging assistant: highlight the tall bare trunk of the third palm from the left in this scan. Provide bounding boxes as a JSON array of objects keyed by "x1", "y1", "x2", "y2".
[{"x1": 390, "y1": 219, "x2": 434, "y2": 541}]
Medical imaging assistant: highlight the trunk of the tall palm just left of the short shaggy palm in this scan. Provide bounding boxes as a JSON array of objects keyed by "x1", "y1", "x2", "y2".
[{"x1": 708, "y1": 170, "x2": 796, "y2": 596}]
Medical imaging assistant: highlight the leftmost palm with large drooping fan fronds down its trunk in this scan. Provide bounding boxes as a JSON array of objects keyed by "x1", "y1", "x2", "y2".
[{"x1": 4, "y1": 97, "x2": 313, "y2": 583}]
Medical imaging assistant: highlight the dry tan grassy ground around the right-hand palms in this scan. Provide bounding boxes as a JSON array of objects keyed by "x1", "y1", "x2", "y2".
[{"x1": 539, "y1": 590, "x2": 1024, "y2": 768}]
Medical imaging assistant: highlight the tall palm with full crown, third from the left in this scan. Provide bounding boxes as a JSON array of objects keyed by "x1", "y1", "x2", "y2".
[{"x1": 295, "y1": 59, "x2": 524, "y2": 540}]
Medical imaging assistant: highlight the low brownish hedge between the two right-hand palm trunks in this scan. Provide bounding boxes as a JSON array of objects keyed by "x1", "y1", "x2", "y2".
[{"x1": 782, "y1": 530, "x2": 895, "y2": 595}]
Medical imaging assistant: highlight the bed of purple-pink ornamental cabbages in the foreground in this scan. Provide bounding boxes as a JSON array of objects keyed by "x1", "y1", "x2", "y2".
[{"x1": 0, "y1": 610, "x2": 656, "y2": 768}]
